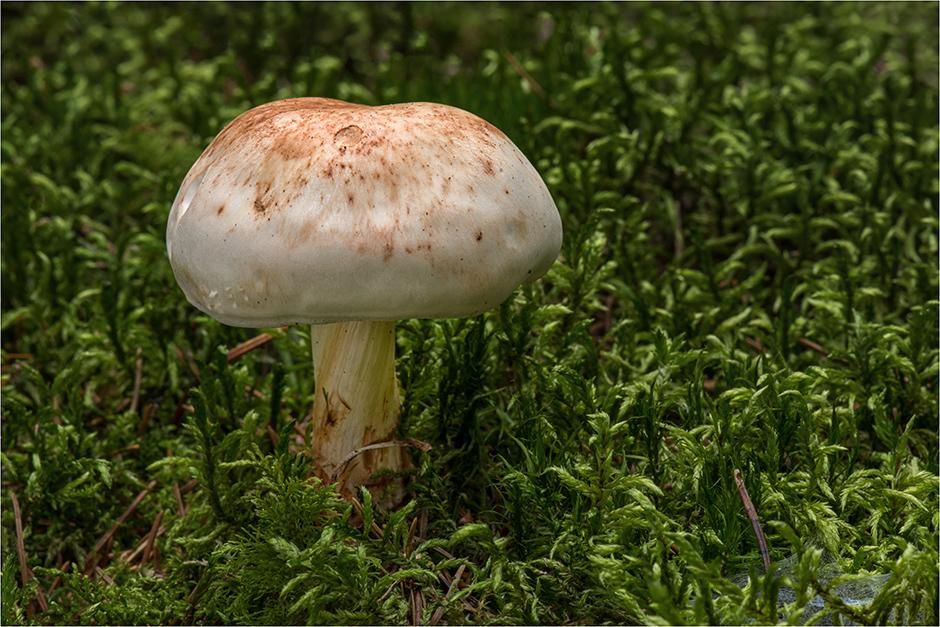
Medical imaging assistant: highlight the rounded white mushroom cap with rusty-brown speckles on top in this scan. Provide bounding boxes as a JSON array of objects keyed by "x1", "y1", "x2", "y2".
[{"x1": 166, "y1": 98, "x2": 562, "y2": 327}]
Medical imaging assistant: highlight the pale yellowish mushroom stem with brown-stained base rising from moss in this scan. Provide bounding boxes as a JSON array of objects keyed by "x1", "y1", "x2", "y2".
[{"x1": 310, "y1": 321, "x2": 410, "y2": 504}]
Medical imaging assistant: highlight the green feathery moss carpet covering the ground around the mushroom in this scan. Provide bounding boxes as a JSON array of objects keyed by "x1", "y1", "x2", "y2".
[{"x1": 0, "y1": 3, "x2": 940, "y2": 624}]
